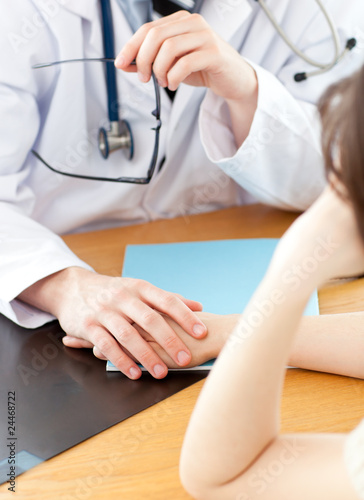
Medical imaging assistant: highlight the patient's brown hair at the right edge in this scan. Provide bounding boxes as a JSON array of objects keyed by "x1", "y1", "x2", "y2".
[{"x1": 319, "y1": 66, "x2": 364, "y2": 241}]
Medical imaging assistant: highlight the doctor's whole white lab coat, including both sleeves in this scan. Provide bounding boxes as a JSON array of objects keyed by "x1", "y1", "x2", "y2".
[{"x1": 0, "y1": 0, "x2": 364, "y2": 327}]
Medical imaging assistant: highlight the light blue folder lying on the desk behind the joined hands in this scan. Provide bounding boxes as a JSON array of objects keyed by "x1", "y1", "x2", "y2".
[{"x1": 123, "y1": 238, "x2": 319, "y2": 315}]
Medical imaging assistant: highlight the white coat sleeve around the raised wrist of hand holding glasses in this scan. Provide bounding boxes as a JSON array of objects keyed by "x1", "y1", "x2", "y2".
[{"x1": 199, "y1": 63, "x2": 325, "y2": 210}]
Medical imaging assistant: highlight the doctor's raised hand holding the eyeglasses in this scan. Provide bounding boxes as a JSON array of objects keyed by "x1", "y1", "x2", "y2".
[{"x1": 115, "y1": 11, "x2": 258, "y2": 146}]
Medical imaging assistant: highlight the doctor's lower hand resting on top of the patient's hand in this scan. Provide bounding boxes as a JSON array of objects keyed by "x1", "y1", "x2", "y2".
[{"x1": 18, "y1": 267, "x2": 207, "y2": 379}]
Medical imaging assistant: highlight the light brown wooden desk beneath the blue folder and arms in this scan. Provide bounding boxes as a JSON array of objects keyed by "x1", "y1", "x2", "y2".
[{"x1": 0, "y1": 205, "x2": 364, "y2": 500}]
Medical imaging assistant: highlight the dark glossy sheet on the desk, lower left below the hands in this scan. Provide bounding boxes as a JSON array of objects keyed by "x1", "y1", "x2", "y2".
[{"x1": 0, "y1": 315, "x2": 206, "y2": 484}]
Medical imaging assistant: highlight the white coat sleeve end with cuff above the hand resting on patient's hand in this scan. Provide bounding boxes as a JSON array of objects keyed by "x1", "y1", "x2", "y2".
[{"x1": 0, "y1": 201, "x2": 91, "y2": 328}]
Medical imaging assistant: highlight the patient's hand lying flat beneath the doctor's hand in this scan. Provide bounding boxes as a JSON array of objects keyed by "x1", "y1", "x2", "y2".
[{"x1": 135, "y1": 312, "x2": 239, "y2": 368}]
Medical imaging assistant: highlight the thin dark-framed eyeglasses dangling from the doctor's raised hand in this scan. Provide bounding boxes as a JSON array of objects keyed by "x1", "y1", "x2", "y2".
[{"x1": 32, "y1": 57, "x2": 162, "y2": 184}]
